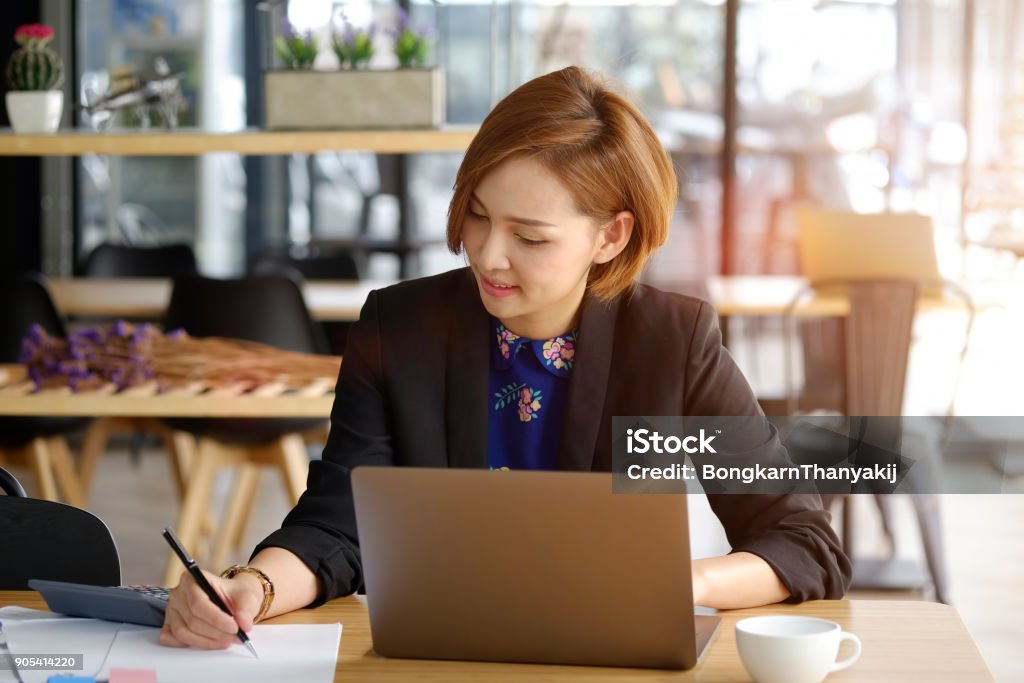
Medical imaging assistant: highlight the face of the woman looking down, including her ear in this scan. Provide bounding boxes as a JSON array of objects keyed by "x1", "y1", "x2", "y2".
[{"x1": 462, "y1": 153, "x2": 632, "y2": 339}]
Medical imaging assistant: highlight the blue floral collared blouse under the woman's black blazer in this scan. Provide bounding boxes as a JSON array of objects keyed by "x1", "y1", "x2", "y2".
[{"x1": 487, "y1": 317, "x2": 577, "y2": 470}]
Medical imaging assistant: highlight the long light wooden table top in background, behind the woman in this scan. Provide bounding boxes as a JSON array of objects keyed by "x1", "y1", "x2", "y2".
[{"x1": 46, "y1": 275, "x2": 1007, "y2": 321}]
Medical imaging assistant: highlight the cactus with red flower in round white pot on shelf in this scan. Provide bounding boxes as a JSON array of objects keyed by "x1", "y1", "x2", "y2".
[{"x1": 5, "y1": 24, "x2": 63, "y2": 133}]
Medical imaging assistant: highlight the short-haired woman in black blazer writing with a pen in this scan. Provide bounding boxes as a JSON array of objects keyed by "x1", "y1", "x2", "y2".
[{"x1": 161, "y1": 68, "x2": 850, "y2": 648}]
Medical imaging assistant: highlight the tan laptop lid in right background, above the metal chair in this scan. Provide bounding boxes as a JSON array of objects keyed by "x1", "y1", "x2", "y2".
[{"x1": 796, "y1": 205, "x2": 942, "y2": 283}]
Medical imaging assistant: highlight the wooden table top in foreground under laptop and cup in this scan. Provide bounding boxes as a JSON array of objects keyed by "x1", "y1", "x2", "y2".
[{"x1": 0, "y1": 591, "x2": 992, "y2": 683}]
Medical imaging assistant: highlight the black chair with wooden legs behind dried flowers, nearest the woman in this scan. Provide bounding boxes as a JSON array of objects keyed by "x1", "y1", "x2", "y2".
[{"x1": 157, "y1": 276, "x2": 328, "y2": 584}]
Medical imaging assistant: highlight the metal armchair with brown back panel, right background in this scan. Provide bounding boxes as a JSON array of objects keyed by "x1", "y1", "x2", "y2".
[{"x1": 784, "y1": 280, "x2": 974, "y2": 602}]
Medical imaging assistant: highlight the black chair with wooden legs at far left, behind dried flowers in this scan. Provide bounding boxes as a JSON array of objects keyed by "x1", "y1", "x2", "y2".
[{"x1": 0, "y1": 273, "x2": 90, "y2": 507}]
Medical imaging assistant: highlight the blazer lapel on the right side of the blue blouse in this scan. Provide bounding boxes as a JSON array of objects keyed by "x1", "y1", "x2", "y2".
[{"x1": 558, "y1": 294, "x2": 621, "y2": 470}]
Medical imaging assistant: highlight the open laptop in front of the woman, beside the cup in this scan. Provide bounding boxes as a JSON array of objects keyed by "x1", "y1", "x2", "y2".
[{"x1": 352, "y1": 467, "x2": 721, "y2": 669}]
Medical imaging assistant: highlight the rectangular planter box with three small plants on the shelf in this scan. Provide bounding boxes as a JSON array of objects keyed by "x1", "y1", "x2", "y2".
[{"x1": 263, "y1": 10, "x2": 444, "y2": 129}]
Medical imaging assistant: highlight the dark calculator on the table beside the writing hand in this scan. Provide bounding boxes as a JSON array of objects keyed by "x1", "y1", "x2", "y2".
[{"x1": 29, "y1": 579, "x2": 171, "y2": 627}]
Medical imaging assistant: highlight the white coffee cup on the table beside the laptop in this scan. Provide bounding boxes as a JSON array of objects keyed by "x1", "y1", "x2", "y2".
[{"x1": 736, "y1": 616, "x2": 860, "y2": 683}]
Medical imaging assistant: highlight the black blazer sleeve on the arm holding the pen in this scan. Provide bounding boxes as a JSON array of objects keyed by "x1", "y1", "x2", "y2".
[{"x1": 253, "y1": 292, "x2": 393, "y2": 606}]
